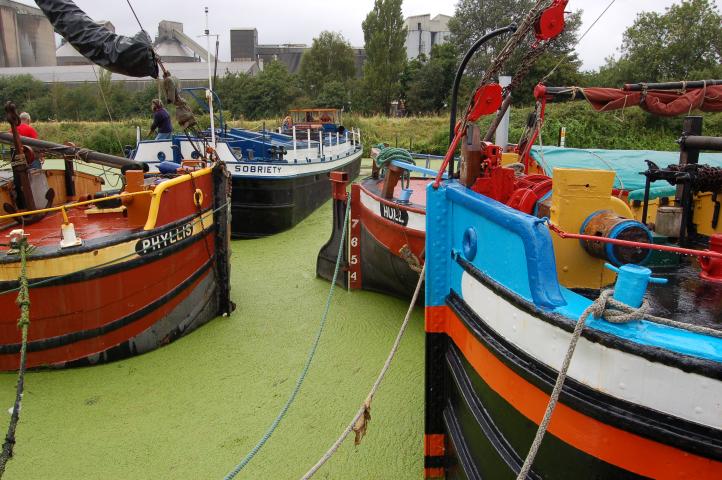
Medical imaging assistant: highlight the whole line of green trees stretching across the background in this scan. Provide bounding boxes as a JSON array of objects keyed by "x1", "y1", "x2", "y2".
[{"x1": 0, "y1": 0, "x2": 722, "y2": 121}]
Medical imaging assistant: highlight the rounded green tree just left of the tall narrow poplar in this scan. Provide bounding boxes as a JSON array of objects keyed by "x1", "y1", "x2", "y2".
[{"x1": 299, "y1": 32, "x2": 356, "y2": 97}]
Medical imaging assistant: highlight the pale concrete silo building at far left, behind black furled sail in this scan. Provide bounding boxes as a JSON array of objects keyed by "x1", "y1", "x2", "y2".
[{"x1": 0, "y1": 0, "x2": 55, "y2": 68}]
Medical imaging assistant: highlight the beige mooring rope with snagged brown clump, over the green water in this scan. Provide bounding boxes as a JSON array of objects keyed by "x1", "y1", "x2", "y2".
[{"x1": 302, "y1": 264, "x2": 426, "y2": 480}]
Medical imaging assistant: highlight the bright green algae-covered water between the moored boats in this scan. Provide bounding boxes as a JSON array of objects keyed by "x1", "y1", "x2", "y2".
[{"x1": 0, "y1": 199, "x2": 424, "y2": 479}]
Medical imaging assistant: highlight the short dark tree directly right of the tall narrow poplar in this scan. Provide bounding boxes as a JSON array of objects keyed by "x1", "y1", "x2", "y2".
[{"x1": 405, "y1": 44, "x2": 456, "y2": 113}]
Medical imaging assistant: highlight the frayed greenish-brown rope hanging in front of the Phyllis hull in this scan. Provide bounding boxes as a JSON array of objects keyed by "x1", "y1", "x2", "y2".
[{"x1": 0, "y1": 237, "x2": 30, "y2": 478}]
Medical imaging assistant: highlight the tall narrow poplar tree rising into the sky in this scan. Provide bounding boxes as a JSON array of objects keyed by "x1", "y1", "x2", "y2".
[{"x1": 362, "y1": 0, "x2": 406, "y2": 112}]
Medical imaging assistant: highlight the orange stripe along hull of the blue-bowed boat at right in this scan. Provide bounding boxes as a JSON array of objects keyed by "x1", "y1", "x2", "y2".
[{"x1": 426, "y1": 306, "x2": 722, "y2": 480}]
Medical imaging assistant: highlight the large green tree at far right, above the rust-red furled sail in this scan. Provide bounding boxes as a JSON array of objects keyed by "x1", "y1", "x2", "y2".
[{"x1": 607, "y1": 0, "x2": 722, "y2": 82}]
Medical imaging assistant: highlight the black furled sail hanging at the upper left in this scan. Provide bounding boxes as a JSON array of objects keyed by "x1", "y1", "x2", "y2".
[{"x1": 35, "y1": 0, "x2": 158, "y2": 78}]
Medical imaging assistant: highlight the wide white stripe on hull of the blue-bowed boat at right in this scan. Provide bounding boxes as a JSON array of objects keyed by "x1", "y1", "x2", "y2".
[{"x1": 461, "y1": 272, "x2": 722, "y2": 429}]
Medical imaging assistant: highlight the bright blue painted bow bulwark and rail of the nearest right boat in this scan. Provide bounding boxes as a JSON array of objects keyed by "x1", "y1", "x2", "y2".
[{"x1": 426, "y1": 181, "x2": 722, "y2": 362}]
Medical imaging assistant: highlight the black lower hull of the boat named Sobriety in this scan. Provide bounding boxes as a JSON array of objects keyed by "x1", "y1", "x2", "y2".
[{"x1": 231, "y1": 156, "x2": 361, "y2": 238}]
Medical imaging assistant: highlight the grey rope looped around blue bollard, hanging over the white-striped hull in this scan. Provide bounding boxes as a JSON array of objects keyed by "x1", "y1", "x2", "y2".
[{"x1": 516, "y1": 289, "x2": 722, "y2": 480}]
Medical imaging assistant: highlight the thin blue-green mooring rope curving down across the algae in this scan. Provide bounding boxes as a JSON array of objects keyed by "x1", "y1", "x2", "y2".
[{"x1": 224, "y1": 199, "x2": 351, "y2": 480}]
